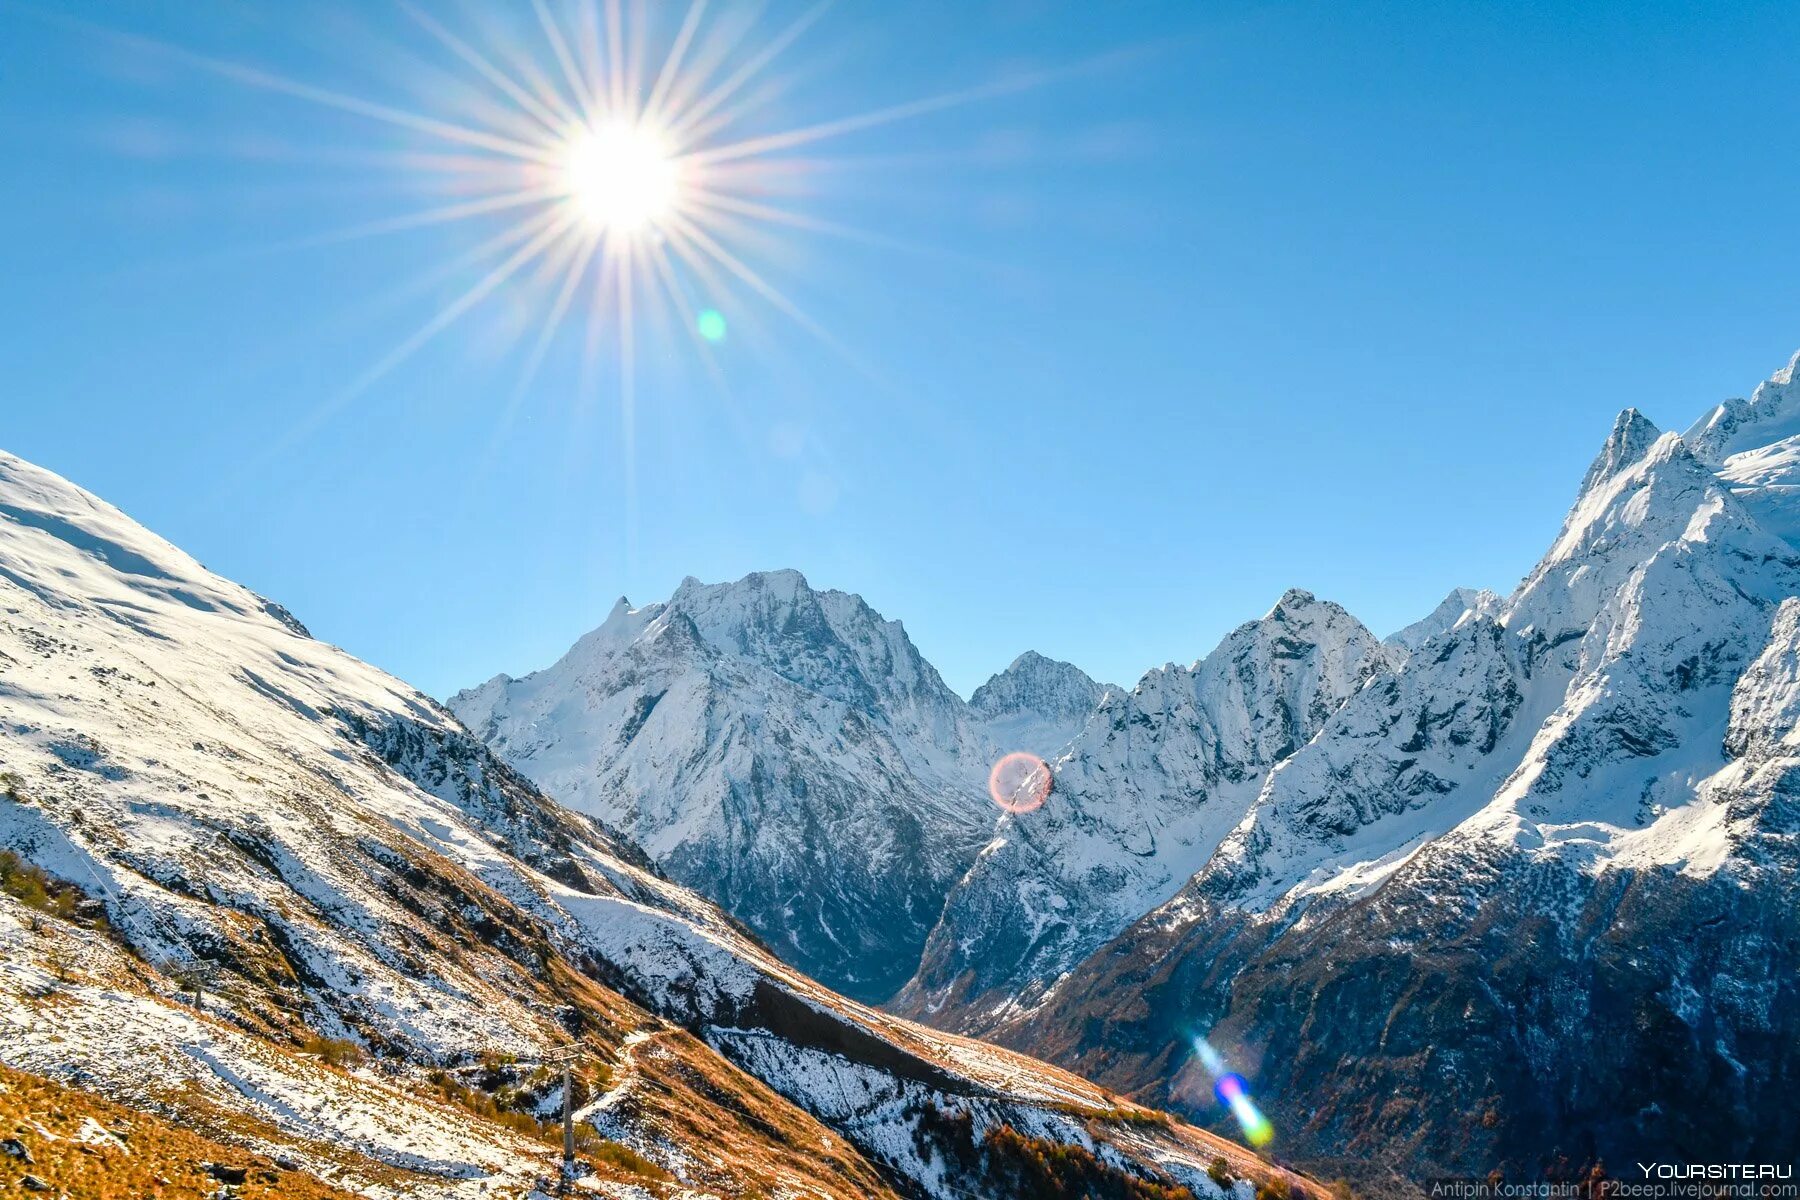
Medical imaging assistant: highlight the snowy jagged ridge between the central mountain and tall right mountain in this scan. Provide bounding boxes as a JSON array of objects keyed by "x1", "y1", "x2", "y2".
[{"x1": 896, "y1": 590, "x2": 1390, "y2": 1031}]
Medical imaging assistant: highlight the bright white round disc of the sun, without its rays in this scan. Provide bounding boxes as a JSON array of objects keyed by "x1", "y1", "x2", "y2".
[{"x1": 558, "y1": 117, "x2": 682, "y2": 237}]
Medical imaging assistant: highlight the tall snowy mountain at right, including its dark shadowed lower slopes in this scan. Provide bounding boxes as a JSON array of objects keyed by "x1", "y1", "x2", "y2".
[{"x1": 986, "y1": 354, "x2": 1800, "y2": 1175}]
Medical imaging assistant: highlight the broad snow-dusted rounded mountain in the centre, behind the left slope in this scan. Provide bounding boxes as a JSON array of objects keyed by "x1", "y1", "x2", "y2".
[{"x1": 450, "y1": 570, "x2": 994, "y2": 1000}]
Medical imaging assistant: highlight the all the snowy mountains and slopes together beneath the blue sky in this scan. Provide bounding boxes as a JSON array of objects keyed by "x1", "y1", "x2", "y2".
[{"x1": 0, "y1": 349, "x2": 1800, "y2": 1200}]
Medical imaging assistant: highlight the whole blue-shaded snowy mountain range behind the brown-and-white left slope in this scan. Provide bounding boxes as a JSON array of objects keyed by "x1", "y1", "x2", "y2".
[{"x1": 450, "y1": 347, "x2": 1800, "y2": 1177}]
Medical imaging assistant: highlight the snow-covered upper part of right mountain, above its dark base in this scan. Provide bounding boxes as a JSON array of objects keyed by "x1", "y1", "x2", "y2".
[{"x1": 1195, "y1": 414, "x2": 1800, "y2": 905}]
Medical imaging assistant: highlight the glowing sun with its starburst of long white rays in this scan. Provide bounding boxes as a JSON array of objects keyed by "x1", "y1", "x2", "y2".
[{"x1": 153, "y1": 0, "x2": 1049, "y2": 456}]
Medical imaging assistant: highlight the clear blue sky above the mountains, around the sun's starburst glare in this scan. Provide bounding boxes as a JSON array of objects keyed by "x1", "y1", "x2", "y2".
[{"x1": 0, "y1": 0, "x2": 1800, "y2": 694}]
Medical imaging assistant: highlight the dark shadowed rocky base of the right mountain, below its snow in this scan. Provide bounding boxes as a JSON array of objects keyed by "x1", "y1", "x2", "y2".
[{"x1": 1008, "y1": 835, "x2": 1800, "y2": 1178}]
